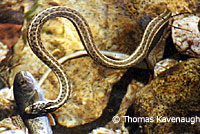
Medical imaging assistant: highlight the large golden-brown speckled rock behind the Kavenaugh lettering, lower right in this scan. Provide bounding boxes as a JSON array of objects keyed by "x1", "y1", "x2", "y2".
[{"x1": 134, "y1": 59, "x2": 200, "y2": 133}]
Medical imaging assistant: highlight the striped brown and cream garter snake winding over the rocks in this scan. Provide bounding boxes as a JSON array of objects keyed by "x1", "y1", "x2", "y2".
[{"x1": 25, "y1": 6, "x2": 171, "y2": 114}]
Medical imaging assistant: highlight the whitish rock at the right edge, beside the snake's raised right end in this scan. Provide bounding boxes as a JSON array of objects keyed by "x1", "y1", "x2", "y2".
[{"x1": 172, "y1": 15, "x2": 200, "y2": 57}]
